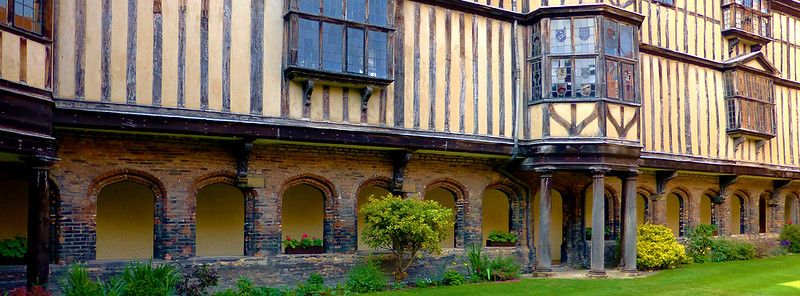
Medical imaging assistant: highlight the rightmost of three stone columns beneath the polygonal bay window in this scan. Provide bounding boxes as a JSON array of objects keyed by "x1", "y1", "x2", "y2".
[{"x1": 622, "y1": 172, "x2": 639, "y2": 273}]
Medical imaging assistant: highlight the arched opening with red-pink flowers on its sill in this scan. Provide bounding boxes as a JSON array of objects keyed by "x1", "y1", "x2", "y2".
[{"x1": 281, "y1": 184, "x2": 325, "y2": 252}]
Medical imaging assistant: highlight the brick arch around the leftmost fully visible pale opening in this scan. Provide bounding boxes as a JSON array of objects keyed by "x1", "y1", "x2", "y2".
[{"x1": 87, "y1": 169, "x2": 168, "y2": 259}]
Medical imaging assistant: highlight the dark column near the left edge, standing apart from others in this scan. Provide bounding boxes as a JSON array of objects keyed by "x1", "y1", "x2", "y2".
[{"x1": 25, "y1": 157, "x2": 53, "y2": 286}]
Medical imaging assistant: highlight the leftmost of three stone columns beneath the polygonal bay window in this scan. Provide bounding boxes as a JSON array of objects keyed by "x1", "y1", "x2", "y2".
[{"x1": 536, "y1": 170, "x2": 553, "y2": 273}]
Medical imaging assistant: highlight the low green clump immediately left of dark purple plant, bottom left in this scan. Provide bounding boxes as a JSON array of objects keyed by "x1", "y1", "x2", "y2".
[{"x1": 122, "y1": 262, "x2": 179, "y2": 296}]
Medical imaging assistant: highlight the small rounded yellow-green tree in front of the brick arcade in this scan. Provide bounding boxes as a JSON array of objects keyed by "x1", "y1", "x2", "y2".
[{"x1": 361, "y1": 194, "x2": 453, "y2": 282}]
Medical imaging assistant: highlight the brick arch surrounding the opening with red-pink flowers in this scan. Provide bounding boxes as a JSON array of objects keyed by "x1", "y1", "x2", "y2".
[{"x1": 278, "y1": 173, "x2": 339, "y2": 252}]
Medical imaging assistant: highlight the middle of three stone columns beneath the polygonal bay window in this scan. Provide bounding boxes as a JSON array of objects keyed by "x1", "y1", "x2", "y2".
[{"x1": 589, "y1": 168, "x2": 609, "y2": 276}]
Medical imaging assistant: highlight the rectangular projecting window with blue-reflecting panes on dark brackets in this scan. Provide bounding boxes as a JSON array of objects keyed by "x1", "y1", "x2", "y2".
[{"x1": 286, "y1": 0, "x2": 394, "y2": 84}]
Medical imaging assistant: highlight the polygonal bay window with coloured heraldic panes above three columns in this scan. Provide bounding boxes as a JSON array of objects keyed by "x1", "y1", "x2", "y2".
[{"x1": 528, "y1": 16, "x2": 639, "y2": 103}]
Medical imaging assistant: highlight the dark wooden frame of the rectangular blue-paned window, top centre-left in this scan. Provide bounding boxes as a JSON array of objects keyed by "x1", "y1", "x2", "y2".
[{"x1": 284, "y1": 0, "x2": 395, "y2": 86}]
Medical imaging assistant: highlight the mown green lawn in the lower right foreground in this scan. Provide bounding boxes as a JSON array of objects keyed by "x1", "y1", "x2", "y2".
[{"x1": 374, "y1": 255, "x2": 800, "y2": 296}]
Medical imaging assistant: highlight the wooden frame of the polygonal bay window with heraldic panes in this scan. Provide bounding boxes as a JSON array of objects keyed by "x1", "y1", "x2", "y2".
[{"x1": 526, "y1": 15, "x2": 641, "y2": 106}]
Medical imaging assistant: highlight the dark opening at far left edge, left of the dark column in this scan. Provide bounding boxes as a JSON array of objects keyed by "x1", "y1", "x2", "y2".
[{"x1": 0, "y1": 179, "x2": 28, "y2": 240}]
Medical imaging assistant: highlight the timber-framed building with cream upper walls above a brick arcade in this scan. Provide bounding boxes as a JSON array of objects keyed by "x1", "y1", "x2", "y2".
[{"x1": 0, "y1": 0, "x2": 800, "y2": 285}]
